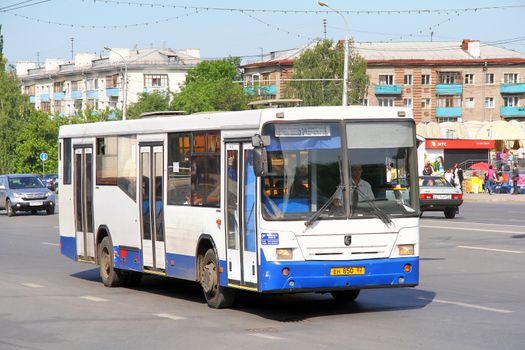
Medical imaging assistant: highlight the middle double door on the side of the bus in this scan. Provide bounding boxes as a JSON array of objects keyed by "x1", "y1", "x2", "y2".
[{"x1": 140, "y1": 144, "x2": 166, "y2": 270}]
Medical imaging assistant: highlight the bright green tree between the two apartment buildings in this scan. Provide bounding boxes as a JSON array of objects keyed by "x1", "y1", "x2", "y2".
[{"x1": 171, "y1": 58, "x2": 248, "y2": 113}]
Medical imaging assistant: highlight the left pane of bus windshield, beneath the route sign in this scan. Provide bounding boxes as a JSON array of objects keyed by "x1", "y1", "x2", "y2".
[{"x1": 262, "y1": 123, "x2": 345, "y2": 220}]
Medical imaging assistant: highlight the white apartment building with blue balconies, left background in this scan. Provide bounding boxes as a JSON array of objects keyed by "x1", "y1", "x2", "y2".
[{"x1": 16, "y1": 48, "x2": 200, "y2": 115}]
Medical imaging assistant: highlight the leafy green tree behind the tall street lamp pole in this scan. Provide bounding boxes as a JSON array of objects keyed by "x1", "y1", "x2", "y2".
[{"x1": 285, "y1": 40, "x2": 369, "y2": 106}]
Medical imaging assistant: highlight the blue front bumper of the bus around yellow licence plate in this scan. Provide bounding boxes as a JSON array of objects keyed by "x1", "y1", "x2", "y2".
[{"x1": 259, "y1": 250, "x2": 419, "y2": 292}]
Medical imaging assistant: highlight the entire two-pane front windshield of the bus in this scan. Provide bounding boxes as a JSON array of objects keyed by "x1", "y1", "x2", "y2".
[{"x1": 262, "y1": 121, "x2": 417, "y2": 222}]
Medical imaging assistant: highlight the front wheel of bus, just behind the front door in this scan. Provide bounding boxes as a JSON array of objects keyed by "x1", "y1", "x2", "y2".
[{"x1": 199, "y1": 249, "x2": 235, "y2": 309}]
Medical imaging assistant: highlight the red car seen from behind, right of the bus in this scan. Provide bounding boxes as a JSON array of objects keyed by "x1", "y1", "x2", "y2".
[{"x1": 419, "y1": 176, "x2": 463, "y2": 219}]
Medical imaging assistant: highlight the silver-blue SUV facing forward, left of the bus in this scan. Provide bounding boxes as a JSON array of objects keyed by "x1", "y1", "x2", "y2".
[{"x1": 0, "y1": 174, "x2": 56, "y2": 216}]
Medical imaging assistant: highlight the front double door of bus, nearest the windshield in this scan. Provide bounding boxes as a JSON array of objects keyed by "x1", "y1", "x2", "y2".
[{"x1": 225, "y1": 142, "x2": 258, "y2": 290}]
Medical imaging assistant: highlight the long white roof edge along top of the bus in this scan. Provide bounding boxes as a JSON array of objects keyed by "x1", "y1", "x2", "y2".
[{"x1": 59, "y1": 106, "x2": 413, "y2": 138}]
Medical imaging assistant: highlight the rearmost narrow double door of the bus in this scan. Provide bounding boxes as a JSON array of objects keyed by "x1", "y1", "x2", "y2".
[{"x1": 73, "y1": 145, "x2": 95, "y2": 261}]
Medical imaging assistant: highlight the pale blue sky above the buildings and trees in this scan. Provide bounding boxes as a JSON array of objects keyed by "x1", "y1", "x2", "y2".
[{"x1": 0, "y1": 0, "x2": 525, "y2": 63}]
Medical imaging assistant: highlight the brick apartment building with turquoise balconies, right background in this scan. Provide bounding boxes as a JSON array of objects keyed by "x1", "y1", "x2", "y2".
[{"x1": 244, "y1": 39, "x2": 525, "y2": 122}]
